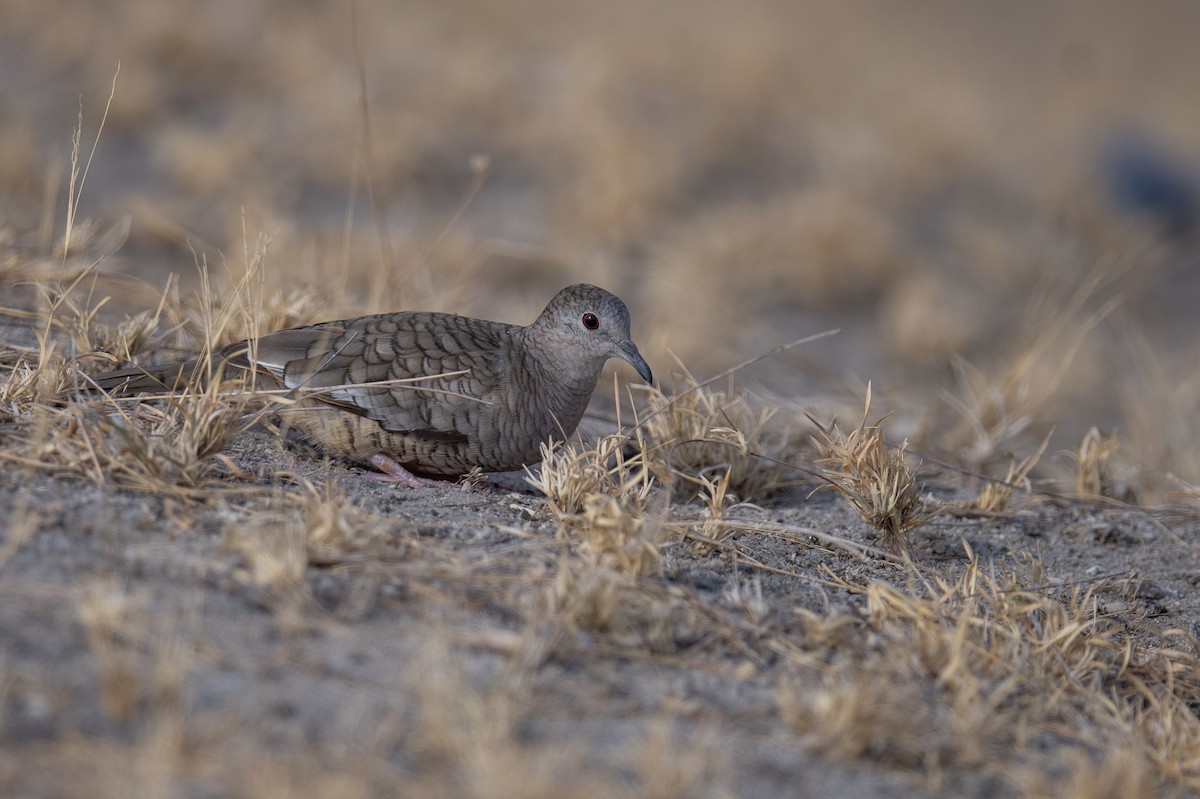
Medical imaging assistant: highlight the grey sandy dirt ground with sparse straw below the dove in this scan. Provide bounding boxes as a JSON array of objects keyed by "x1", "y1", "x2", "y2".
[{"x1": 0, "y1": 410, "x2": 1200, "y2": 797}]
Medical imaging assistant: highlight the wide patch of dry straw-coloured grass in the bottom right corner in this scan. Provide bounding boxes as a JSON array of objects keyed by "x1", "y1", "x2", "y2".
[{"x1": 780, "y1": 560, "x2": 1200, "y2": 795}]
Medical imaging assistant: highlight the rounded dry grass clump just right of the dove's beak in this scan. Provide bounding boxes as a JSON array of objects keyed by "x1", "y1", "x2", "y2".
[{"x1": 642, "y1": 378, "x2": 787, "y2": 503}]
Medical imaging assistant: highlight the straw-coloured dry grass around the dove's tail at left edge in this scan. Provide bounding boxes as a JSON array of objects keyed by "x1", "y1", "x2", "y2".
[{"x1": 0, "y1": 218, "x2": 328, "y2": 495}]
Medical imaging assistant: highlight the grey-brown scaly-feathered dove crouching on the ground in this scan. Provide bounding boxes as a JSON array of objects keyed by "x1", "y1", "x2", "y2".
[{"x1": 94, "y1": 283, "x2": 654, "y2": 488}]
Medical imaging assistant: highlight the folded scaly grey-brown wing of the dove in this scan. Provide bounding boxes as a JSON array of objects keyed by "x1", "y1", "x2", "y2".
[{"x1": 231, "y1": 313, "x2": 515, "y2": 440}]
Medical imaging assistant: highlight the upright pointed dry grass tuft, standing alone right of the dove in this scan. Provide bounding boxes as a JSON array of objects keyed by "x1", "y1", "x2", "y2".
[{"x1": 812, "y1": 384, "x2": 930, "y2": 553}]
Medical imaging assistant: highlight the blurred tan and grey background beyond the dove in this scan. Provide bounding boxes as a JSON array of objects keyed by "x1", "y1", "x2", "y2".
[{"x1": 0, "y1": 0, "x2": 1200, "y2": 491}]
